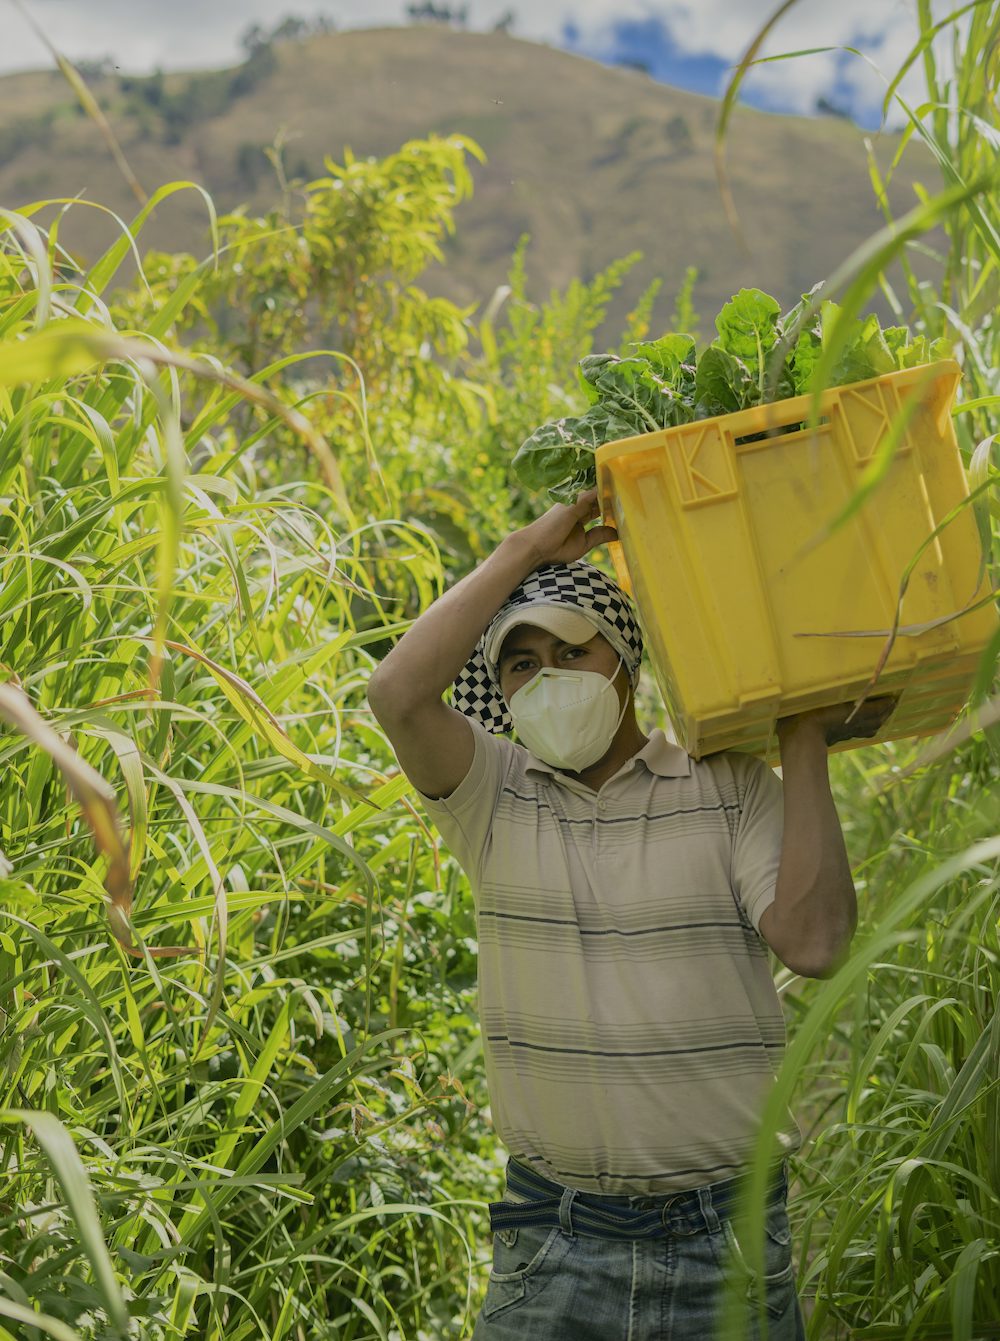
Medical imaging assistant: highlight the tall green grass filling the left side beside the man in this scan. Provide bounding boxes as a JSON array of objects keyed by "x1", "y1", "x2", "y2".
[{"x1": 0, "y1": 191, "x2": 495, "y2": 1341}]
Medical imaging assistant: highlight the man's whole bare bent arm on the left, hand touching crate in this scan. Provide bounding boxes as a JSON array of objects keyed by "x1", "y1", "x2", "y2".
[{"x1": 369, "y1": 489, "x2": 615, "y2": 797}]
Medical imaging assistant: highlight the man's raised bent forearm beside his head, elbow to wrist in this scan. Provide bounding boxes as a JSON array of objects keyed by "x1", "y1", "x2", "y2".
[{"x1": 369, "y1": 531, "x2": 542, "y2": 712}]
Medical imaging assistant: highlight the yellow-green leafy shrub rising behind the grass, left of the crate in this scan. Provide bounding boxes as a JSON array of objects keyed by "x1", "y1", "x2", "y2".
[{"x1": 115, "y1": 137, "x2": 500, "y2": 581}]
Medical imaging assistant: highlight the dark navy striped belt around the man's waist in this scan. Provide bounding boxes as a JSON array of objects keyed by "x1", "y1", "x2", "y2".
[{"x1": 489, "y1": 1159, "x2": 788, "y2": 1239}]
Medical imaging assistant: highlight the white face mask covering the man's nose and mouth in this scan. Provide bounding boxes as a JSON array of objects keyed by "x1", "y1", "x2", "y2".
[{"x1": 508, "y1": 661, "x2": 629, "y2": 772}]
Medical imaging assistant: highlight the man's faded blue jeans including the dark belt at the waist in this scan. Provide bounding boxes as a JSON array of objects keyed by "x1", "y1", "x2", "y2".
[{"x1": 473, "y1": 1165, "x2": 806, "y2": 1341}]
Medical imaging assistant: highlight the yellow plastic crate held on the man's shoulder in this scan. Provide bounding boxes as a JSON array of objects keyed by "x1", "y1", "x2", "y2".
[{"x1": 597, "y1": 359, "x2": 997, "y2": 759}]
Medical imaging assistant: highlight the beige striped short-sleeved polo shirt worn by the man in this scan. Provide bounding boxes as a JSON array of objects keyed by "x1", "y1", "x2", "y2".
[{"x1": 424, "y1": 721, "x2": 802, "y2": 1195}]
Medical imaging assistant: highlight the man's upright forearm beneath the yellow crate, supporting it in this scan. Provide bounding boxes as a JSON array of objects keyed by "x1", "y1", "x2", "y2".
[{"x1": 768, "y1": 723, "x2": 858, "y2": 978}]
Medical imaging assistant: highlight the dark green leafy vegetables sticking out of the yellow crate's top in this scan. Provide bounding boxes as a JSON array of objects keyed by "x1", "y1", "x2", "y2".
[{"x1": 513, "y1": 288, "x2": 949, "y2": 503}]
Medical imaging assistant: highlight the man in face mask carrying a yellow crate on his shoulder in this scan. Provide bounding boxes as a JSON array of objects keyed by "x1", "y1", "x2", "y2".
[{"x1": 369, "y1": 492, "x2": 885, "y2": 1341}]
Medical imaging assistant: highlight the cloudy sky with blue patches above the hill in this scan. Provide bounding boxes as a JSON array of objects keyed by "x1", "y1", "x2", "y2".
[{"x1": 0, "y1": 0, "x2": 920, "y2": 126}]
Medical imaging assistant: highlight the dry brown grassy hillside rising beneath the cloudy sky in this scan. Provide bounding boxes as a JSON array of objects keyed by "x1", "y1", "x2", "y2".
[{"x1": 0, "y1": 27, "x2": 913, "y2": 325}]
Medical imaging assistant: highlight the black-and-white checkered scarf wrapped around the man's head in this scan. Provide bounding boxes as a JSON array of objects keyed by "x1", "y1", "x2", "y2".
[{"x1": 452, "y1": 562, "x2": 642, "y2": 736}]
